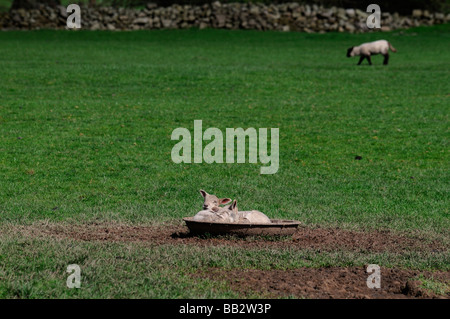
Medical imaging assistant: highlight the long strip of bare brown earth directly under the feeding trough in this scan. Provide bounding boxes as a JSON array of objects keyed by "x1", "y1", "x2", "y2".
[{"x1": 12, "y1": 224, "x2": 447, "y2": 252}]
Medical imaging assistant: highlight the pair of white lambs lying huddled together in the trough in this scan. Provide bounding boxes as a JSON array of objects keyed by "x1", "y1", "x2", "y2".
[{"x1": 194, "y1": 189, "x2": 271, "y2": 224}]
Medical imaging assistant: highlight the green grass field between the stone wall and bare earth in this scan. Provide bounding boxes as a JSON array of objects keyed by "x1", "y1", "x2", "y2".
[{"x1": 0, "y1": 25, "x2": 450, "y2": 298}]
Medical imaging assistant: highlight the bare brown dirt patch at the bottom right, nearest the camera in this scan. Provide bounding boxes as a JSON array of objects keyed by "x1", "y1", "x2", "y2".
[{"x1": 194, "y1": 267, "x2": 450, "y2": 299}]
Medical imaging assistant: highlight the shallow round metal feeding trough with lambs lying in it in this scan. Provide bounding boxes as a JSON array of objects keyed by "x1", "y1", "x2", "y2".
[{"x1": 183, "y1": 217, "x2": 300, "y2": 236}]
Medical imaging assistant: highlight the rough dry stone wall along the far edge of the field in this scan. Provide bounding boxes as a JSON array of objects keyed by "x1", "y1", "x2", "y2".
[{"x1": 0, "y1": 1, "x2": 450, "y2": 32}]
